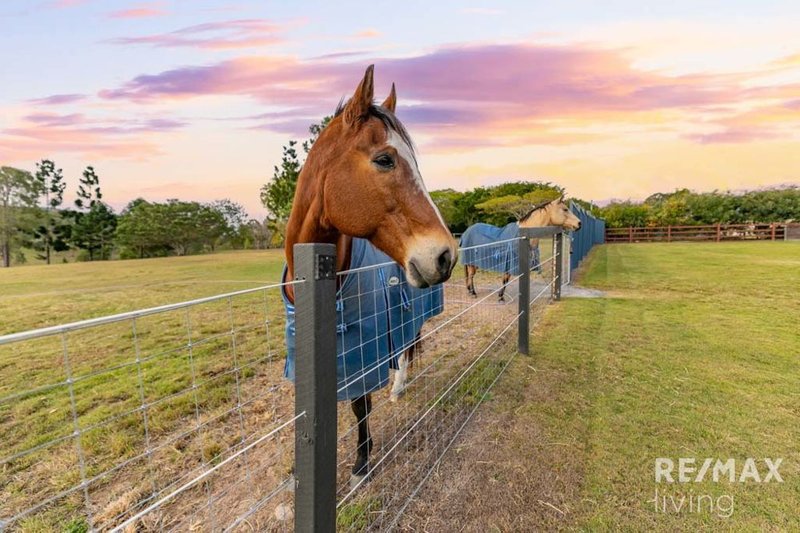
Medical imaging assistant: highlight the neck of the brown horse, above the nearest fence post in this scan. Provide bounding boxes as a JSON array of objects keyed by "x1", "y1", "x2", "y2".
[{"x1": 283, "y1": 164, "x2": 352, "y2": 301}]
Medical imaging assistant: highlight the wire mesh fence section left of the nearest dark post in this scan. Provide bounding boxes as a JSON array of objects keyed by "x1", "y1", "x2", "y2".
[{"x1": 0, "y1": 285, "x2": 304, "y2": 531}]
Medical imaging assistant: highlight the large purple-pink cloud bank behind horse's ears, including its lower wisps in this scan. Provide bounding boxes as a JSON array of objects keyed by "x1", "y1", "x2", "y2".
[{"x1": 99, "y1": 41, "x2": 790, "y2": 149}]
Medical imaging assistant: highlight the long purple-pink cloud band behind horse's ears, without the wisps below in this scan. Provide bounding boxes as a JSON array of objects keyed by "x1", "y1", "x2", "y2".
[{"x1": 101, "y1": 45, "x2": 734, "y2": 111}]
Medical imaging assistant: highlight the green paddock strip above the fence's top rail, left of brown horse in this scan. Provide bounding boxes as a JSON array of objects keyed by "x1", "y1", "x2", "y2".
[{"x1": 0, "y1": 250, "x2": 283, "y2": 335}]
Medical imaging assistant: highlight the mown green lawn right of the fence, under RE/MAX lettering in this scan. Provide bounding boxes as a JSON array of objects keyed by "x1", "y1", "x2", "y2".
[{"x1": 528, "y1": 243, "x2": 800, "y2": 531}]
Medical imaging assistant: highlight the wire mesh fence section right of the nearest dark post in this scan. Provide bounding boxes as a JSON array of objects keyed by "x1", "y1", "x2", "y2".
[{"x1": 337, "y1": 235, "x2": 554, "y2": 531}]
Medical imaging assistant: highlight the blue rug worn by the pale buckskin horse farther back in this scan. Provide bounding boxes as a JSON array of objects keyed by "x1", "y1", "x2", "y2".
[{"x1": 461, "y1": 222, "x2": 542, "y2": 276}]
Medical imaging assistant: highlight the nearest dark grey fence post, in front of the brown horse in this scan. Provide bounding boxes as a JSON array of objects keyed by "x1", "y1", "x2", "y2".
[{"x1": 294, "y1": 244, "x2": 336, "y2": 533}]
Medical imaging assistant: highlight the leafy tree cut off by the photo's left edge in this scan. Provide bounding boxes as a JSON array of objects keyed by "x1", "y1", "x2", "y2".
[{"x1": 0, "y1": 167, "x2": 43, "y2": 267}]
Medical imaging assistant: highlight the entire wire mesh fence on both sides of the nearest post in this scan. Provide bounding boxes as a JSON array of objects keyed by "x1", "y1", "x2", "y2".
[{"x1": 0, "y1": 231, "x2": 560, "y2": 531}]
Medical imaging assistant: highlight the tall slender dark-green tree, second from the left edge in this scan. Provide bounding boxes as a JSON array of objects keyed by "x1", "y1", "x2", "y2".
[{"x1": 33, "y1": 159, "x2": 69, "y2": 265}]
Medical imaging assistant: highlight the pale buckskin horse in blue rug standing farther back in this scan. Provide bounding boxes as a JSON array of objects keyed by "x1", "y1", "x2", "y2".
[{"x1": 461, "y1": 196, "x2": 581, "y2": 302}]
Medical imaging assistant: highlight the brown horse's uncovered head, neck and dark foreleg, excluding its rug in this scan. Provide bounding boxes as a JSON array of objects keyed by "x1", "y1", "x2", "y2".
[{"x1": 286, "y1": 66, "x2": 458, "y2": 482}]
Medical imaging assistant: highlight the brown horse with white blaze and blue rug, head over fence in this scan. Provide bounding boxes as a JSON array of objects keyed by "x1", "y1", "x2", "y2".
[{"x1": 283, "y1": 66, "x2": 458, "y2": 486}]
